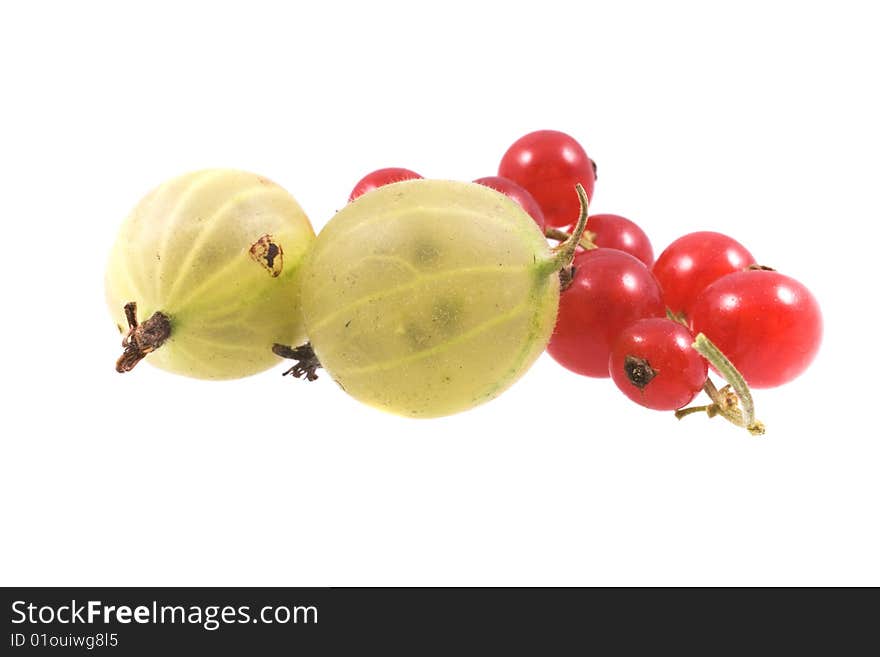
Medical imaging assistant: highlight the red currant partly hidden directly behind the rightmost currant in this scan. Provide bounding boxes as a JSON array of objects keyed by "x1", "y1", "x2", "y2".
[{"x1": 652, "y1": 231, "x2": 755, "y2": 316}]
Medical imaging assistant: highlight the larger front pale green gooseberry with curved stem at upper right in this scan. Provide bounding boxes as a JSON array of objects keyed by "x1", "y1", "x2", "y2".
[{"x1": 302, "y1": 180, "x2": 586, "y2": 417}]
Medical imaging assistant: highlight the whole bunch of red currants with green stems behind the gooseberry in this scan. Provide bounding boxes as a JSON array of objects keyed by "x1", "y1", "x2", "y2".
[{"x1": 350, "y1": 130, "x2": 822, "y2": 434}]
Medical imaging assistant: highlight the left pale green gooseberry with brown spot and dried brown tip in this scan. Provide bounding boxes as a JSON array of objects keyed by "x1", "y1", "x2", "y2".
[{"x1": 106, "y1": 169, "x2": 315, "y2": 379}]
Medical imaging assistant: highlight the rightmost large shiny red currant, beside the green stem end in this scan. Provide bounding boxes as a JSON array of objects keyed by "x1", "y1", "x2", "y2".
[{"x1": 690, "y1": 270, "x2": 822, "y2": 388}]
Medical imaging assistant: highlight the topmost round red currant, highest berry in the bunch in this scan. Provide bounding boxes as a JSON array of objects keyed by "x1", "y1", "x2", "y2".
[{"x1": 498, "y1": 130, "x2": 596, "y2": 228}]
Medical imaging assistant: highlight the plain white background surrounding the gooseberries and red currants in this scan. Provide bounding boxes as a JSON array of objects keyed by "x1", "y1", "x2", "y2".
[{"x1": 0, "y1": 0, "x2": 880, "y2": 585}]
